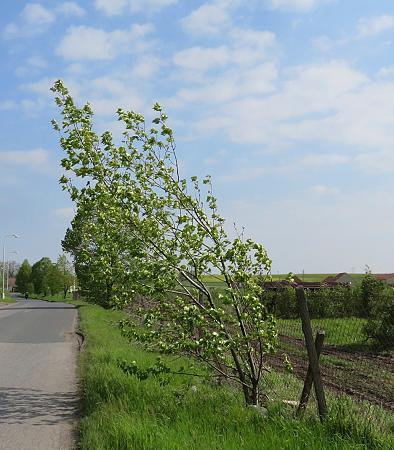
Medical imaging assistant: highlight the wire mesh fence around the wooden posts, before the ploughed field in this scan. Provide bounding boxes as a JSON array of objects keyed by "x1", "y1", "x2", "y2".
[{"x1": 258, "y1": 290, "x2": 394, "y2": 433}]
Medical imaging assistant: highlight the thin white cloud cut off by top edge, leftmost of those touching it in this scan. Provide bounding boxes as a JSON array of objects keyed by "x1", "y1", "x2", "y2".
[{"x1": 95, "y1": 0, "x2": 178, "y2": 16}]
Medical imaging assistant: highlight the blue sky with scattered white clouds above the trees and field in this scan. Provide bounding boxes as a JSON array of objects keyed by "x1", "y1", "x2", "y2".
[{"x1": 0, "y1": 0, "x2": 394, "y2": 273}]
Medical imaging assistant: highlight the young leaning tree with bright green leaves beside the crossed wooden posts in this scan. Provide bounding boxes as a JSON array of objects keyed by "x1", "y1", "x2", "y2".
[{"x1": 53, "y1": 81, "x2": 277, "y2": 405}]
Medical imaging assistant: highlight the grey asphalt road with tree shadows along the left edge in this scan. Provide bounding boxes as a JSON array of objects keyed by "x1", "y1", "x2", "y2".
[{"x1": 0, "y1": 299, "x2": 78, "y2": 450}]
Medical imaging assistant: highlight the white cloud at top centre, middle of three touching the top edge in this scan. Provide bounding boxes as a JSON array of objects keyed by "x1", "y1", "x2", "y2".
[{"x1": 181, "y1": 0, "x2": 238, "y2": 34}]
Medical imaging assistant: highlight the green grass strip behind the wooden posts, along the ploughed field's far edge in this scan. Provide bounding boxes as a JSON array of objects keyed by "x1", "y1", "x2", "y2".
[{"x1": 278, "y1": 317, "x2": 365, "y2": 346}]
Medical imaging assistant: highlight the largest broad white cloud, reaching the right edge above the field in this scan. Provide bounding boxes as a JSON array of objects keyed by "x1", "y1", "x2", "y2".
[{"x1": 196, "y1": 61, "x2": 394, "y2": 149}]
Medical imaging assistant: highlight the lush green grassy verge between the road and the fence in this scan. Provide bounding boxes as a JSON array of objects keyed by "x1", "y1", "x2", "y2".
[{"x1": 68, "y1": 303, "x2": 390, "y2": 450}]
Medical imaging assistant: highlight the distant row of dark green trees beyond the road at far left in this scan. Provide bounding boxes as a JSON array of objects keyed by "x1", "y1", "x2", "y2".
[{"x1": 16, "y1": 255, "x2": 75, "y2": 297}]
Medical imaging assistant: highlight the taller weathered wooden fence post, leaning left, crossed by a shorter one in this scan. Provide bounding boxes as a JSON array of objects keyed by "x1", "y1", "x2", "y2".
[{"x1": 296, "y1": 286, "x2": 327, "y2": 421}]
